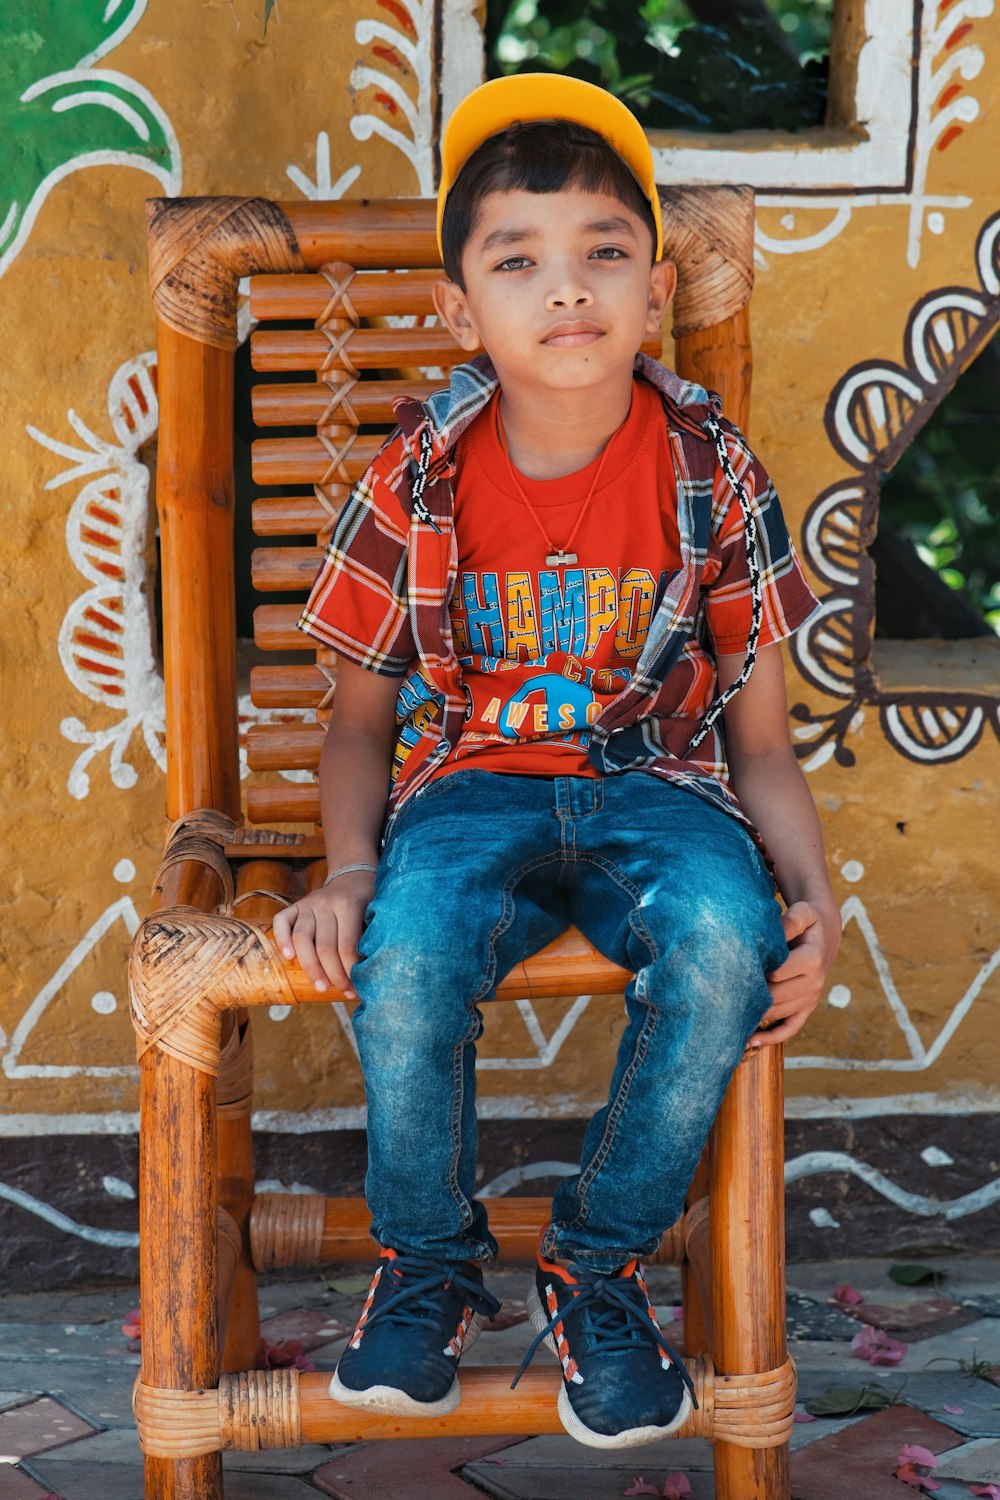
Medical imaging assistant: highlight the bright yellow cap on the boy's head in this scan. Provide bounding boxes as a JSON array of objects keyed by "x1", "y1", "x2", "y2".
[{"x1": 438, "y1": 74, "x2": 663, "y2": 260}]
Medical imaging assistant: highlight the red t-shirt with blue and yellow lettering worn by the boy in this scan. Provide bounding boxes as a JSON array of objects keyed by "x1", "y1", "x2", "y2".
[{"x1": 438, "y1": 381, "x2": 681, "y2": 776}]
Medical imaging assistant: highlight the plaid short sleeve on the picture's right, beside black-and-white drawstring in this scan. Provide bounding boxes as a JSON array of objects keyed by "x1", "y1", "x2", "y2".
[{"x1": 705, "y1": 429, "x2": 819, "y2": 656}]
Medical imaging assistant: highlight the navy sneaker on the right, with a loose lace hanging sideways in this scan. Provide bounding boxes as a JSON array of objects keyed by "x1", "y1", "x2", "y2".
[{"x1": 514, "y1": 1253, "x2": 697, "y2": 1448}]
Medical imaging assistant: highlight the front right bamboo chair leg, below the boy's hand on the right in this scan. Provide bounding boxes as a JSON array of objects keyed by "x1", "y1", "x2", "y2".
[{"x1": 709, "y1": 1047, "x2": 790, "y2": 1500}]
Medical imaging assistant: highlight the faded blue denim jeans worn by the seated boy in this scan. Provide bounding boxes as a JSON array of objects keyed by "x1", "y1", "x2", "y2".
[{"x1": 351, "y1": 771, "x2": 787, "y2": 1271}]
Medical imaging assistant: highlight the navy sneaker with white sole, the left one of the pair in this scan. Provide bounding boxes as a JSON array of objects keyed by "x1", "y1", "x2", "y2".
[{"x1": 330, "y1": 1250, "x2": 501, "y2": 1416}]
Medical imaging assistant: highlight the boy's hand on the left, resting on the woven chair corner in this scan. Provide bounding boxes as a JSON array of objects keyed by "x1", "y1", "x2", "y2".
[{"x1": 273, "y1": 870, "x2": 375, "y2": 1001}]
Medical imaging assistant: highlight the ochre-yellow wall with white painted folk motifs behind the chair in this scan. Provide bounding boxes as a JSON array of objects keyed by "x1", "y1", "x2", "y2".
[{"x1": 0, "y1": 0, "x2": 1000, "y2": 1152}]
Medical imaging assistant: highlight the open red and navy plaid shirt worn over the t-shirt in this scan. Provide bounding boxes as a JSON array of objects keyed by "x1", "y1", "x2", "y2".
[{"x1": 298, "y1": 354, "x2": 816, "y2": 827}]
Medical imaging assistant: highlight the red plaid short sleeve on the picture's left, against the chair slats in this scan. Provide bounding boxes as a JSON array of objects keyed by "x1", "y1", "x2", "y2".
[{"x1": 298, "y1": 435, "x2": 415, "y2": 677}]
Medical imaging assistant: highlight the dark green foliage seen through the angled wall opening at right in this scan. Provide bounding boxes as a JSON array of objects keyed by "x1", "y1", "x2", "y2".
[{"x1": 880, "y1": 342, "x2": 1000, "y2": 635}]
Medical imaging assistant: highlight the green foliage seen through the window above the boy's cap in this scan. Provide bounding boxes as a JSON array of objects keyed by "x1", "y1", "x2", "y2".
[{"x1": 487, "y1": 0, "x2": 832, "y2": 131}]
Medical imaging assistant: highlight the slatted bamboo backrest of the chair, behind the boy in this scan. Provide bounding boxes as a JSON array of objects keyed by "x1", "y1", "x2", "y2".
[{"x1": 148, "y1": 188, "x2": 753, "y2": 834}]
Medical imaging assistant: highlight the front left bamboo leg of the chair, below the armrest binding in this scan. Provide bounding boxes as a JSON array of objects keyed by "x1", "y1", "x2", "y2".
[{"x1": 139, "y1": 1047, "x2": 222, "y2": 1500}]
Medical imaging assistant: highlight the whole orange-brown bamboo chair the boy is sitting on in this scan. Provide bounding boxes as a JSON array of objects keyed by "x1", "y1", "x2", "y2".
[{"x1": 130, "y1": 188, "x2": 795, "y2": 1500}]
